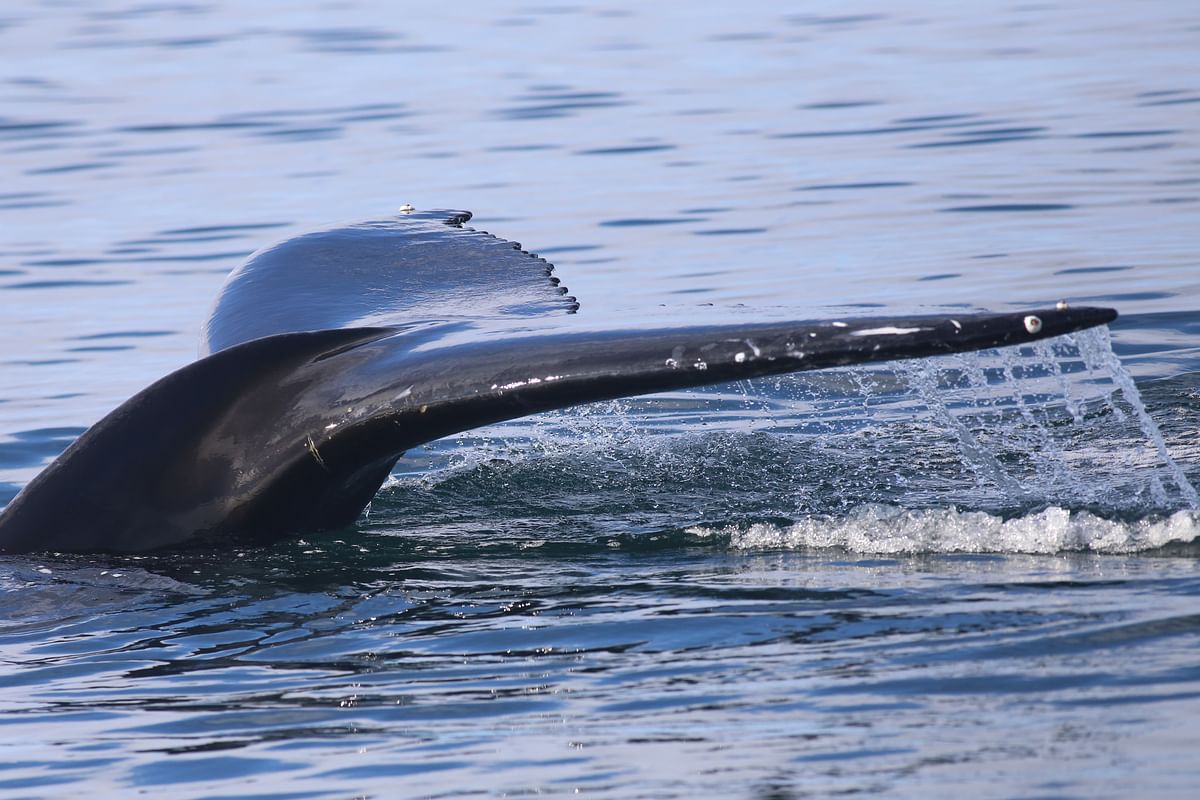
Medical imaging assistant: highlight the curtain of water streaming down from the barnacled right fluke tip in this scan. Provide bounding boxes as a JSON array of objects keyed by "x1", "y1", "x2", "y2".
[{"x1": 900, "y1": 327, "x2": 1200, "y2": 512}]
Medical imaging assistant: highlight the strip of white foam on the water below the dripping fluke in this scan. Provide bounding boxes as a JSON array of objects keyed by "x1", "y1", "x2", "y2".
[{"x1": 689, "y1": 505, "x2": 1200, "y2": 554}]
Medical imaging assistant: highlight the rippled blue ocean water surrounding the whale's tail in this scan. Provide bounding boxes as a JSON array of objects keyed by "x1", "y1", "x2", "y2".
[{"x1": 0, "y1": 0, "x2": 1200, "y2": 799}]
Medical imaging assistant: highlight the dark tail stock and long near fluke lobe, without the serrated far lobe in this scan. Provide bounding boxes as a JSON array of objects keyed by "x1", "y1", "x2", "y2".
[{"x1": 0, "y1": 307, "x2": 1116, "y2": 553}]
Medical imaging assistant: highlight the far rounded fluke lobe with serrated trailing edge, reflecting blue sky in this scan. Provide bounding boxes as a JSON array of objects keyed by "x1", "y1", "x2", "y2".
[{"x1": 203, "y1": 211, "x2": 578, "y2": 353}]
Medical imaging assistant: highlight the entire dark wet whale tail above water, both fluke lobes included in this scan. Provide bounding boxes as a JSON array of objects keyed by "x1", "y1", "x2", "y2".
[{"x1": 0, "y1": 211, "x2": 1116, "y2": 553}]
